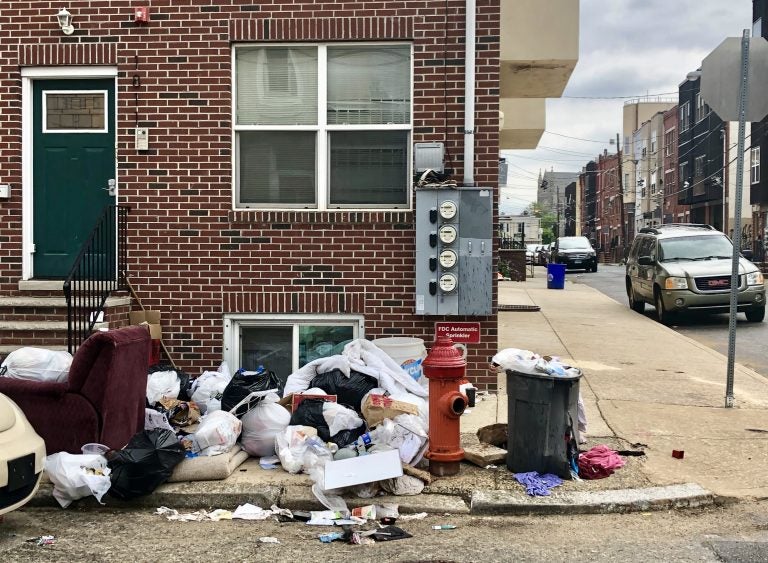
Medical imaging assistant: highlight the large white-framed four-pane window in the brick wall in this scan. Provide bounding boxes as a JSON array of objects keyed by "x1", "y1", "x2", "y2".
[{"x1": 233, "y1": 43, "x2": 413, "y2": 210}]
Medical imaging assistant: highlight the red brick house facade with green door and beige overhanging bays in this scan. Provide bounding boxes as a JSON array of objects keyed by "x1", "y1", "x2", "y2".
[{"x1": 0, "y1": 0, "x2": 578, "y2": 389}]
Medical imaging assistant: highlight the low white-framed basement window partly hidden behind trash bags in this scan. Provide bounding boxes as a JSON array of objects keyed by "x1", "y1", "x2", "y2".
[{"x1": 224, "y1": 313, "x2": 365, "y2": 381}]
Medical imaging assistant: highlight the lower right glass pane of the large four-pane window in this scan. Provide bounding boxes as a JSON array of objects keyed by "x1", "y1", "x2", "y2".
[{"x1": 329, "y1": 131, "x2": 408, "y2": 206}]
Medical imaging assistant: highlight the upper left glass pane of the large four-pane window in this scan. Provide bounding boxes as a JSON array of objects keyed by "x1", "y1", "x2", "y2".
[{"x1": 235, "y1": 47, "x2": 317, "y2": 125}]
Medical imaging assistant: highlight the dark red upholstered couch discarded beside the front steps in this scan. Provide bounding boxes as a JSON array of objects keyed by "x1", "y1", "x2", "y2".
[{"x1": 0, "y1": 326, "x2": 150, "y2": 454}]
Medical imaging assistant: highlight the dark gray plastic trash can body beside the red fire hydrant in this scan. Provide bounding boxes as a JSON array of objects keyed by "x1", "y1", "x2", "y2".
[{"x1": 507, "y1": 370, "x2": 581, "y2": 479}]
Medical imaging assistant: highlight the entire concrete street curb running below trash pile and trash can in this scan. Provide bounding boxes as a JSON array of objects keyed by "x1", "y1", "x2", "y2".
[{"x1": 29, "y1": 481, "x2": 716, "y2": 516}]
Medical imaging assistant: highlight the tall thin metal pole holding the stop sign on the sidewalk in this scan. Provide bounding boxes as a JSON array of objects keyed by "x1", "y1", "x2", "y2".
[{"x1": 723, "y1": 29, "x2": 749, "y2": 408}]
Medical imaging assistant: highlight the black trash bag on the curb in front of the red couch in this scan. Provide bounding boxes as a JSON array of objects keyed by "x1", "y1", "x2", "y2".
[{"x1": 107, "y1": 428, "x2": 186, "y2": 500}]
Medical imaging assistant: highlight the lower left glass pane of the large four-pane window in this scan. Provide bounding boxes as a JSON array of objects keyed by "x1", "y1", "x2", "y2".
[{"x1": 238, "y1": 131, "x2": 317, "y2": 206}]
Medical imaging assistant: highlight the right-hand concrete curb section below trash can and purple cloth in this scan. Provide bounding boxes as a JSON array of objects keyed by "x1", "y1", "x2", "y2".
[{"x1": 470, "y1": 483, "x2": 715, "y2": 515}]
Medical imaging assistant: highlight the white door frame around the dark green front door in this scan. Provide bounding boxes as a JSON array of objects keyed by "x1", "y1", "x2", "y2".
[{"x1": 21, "y1": 66, "x2": 120, "y2": 281}]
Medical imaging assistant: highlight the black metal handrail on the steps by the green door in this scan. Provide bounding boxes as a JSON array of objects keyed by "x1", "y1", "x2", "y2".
[{"x1": 64, "y1": 205, "x2": 130, "y2": 354}]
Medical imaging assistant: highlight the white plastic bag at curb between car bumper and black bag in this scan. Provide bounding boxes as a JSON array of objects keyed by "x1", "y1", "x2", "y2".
[{"x1": 45, "y1": 452, "x2": 112, "y2": 508}]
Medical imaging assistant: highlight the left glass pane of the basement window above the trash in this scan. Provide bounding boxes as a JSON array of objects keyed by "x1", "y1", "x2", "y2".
[{"x1": 242, "y1": 326, "x2": 293, "y2": 381}]
